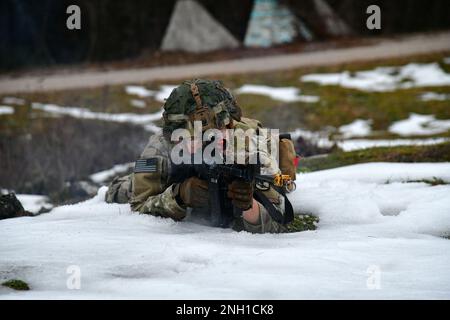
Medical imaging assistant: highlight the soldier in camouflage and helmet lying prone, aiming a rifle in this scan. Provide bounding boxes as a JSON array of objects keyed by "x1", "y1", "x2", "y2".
[{"x1": 106, "y1": 79, "x2": 294, "y2": 233}]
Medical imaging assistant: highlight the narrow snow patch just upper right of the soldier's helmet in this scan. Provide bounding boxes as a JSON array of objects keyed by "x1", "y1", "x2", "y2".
[{"x1": 235, "y1": 84, "x2": 319, "y2": 103}]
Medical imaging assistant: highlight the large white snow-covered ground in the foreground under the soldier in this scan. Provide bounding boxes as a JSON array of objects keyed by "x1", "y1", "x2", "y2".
[{"x1": 0, "y1": 163, "x2": 450, "y2": 299}]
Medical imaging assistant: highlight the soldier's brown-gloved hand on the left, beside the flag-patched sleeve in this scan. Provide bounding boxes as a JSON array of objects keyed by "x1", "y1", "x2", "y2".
[{"x1": 179, "y1": 177, "x2": 209, "y2": 208}]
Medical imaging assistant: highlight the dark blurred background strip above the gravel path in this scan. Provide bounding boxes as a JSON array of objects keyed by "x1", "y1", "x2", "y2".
[{"x1": 0, "y1": 0, "x2": 450, "y2": 71}]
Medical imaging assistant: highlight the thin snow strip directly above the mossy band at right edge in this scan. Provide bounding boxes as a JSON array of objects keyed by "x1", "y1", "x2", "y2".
[{"x1": 337, "y1": 138, "x2": 450, "y2": 151}]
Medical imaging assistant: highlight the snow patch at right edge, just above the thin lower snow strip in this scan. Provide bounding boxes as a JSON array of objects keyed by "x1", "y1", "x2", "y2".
[{"x1": 389, "y1": 113, "x2": 450, "y2": 136}]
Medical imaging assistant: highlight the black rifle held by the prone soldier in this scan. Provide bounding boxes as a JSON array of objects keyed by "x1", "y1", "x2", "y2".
[{"x1": 169, "y1": 160, "x2": 294, "y2": 228}]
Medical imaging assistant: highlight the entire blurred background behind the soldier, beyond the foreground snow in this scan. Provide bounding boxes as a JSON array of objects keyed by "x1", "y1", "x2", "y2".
[{"x1": 0, "y1": 0, "x2": 450, "y2": 213}]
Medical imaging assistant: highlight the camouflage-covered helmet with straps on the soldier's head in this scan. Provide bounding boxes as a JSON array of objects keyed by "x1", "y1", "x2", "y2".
[{"x1": 163, "y1": 79, "x2": 241, "y2": 134}]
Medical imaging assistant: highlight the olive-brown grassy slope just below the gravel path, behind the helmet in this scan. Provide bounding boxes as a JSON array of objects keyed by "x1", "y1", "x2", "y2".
[{"x1": 0, "y1": 52, "x2": 450, "y2": 135}]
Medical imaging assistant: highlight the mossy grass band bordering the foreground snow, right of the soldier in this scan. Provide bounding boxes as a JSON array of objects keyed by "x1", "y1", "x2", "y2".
[{"x1": 299, "y1": 142, "x2": 450, "y2": 172}]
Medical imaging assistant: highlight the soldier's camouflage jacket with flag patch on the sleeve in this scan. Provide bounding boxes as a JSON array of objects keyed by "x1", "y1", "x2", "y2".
[{"x1": 106, "y1": 118, "x2": 286, "y2": 233}]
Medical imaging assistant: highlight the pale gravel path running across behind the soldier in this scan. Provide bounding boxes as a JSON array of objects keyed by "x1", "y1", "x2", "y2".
[{"x1": 0, "y1": 31, "x2": 450, "y2": 94}]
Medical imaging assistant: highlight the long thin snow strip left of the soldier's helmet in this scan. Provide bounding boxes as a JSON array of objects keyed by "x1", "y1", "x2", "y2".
[{"x1": 32, "y1": 103, "x2": 162, "y2": 131}]
